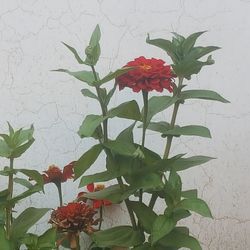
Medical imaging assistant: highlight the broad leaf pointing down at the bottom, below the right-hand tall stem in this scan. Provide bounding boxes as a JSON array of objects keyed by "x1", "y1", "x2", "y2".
[{"x1": 151, "y1": 215, "x2": 176, "y2": 245}]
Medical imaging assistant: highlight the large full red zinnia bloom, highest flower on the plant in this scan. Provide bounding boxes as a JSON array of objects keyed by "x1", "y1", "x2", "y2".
[{"x1": 116, "y1": 56, "x2": 174, "y2": 92}]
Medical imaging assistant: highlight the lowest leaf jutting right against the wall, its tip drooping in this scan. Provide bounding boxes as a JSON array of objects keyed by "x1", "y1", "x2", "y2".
[{"x1": 177, "y1": 198, "x2": 213, "y2": 218}]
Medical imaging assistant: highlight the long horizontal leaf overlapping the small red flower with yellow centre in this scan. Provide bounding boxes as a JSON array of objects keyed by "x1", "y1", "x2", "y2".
[{"x1": 84, "y1": 184, "x2": 135, "y2": 203}]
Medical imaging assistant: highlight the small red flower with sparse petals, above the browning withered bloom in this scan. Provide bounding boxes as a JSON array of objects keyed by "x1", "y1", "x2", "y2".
[{"x1": 43, "y1": 161, "x2": 75, "y2": 183}]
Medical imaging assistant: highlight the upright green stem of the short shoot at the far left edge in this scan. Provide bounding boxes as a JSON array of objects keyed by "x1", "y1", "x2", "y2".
[{"x1": 6, "y1": 158, "x2": 14, "y2": 239}]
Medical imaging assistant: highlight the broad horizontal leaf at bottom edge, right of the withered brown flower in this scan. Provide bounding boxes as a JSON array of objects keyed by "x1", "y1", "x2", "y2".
[{"x1": 92, "y1": 226, "x2": 144, "y2": 247}]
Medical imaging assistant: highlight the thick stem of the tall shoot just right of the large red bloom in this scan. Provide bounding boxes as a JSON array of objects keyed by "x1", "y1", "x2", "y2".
[{"x1": 149, "y1": 77, "x2": 184, "y2": 209}]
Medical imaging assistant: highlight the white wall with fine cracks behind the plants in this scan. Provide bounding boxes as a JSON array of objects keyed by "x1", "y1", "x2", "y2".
[{"x1": 0, "y1": 0, "x2": 250, "y2": 250}]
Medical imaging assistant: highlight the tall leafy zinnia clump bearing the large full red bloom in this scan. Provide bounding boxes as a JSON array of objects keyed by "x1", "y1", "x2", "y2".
[{"x1": 57, "y1": 25, "x2": 228, "y2": 250}]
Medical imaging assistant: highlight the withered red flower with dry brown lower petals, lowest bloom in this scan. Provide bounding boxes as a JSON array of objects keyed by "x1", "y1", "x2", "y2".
[{"x1": 49, "y1": 202, "x2": 99, "y2": 234}]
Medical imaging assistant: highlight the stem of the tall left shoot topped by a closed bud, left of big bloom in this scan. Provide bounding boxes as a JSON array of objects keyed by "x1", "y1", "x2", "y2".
[{"x1": 91, "y1": 65, "x2": 136, "y2": 229}]
